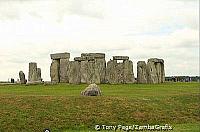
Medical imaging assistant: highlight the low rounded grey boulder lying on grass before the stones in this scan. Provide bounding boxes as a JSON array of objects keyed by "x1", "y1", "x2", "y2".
[{"x1": 81, "y1": 84, "x2": 101, "y2": 96}]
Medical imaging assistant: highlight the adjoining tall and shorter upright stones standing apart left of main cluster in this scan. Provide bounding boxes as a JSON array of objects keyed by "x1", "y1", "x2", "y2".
[{"x1": 28, "y1": 62, "x2": 42, "y2": 83}]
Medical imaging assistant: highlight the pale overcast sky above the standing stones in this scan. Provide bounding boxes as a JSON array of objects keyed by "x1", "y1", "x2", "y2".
[{"x1": 0, "y1": 0, "x2": 199, "y2": 81}]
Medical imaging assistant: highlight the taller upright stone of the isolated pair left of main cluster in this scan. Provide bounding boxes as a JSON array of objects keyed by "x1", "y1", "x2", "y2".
[{"x1": 28, "y1": 62, "x2": 38, "y2": 82}]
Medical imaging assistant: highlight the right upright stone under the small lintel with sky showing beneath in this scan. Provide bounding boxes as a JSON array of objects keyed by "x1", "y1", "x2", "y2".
[{"x1": 123, "y1": 60, "x2": 135, "y2": 83}]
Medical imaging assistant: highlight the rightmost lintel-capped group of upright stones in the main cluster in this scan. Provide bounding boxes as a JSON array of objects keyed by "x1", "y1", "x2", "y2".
[{"x1": 147, "y1": 58, "x2": 165, "y2": 83}]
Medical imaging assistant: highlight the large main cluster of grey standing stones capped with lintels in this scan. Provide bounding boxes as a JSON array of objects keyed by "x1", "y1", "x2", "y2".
[{"x1": 49, "y1": 52, "x2": 165, "y2": 84}]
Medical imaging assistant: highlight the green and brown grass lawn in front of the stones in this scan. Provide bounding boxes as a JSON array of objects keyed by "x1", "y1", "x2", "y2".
[{"x1": 0, "y1": 83, "x2": 200, "y2": 132}]
